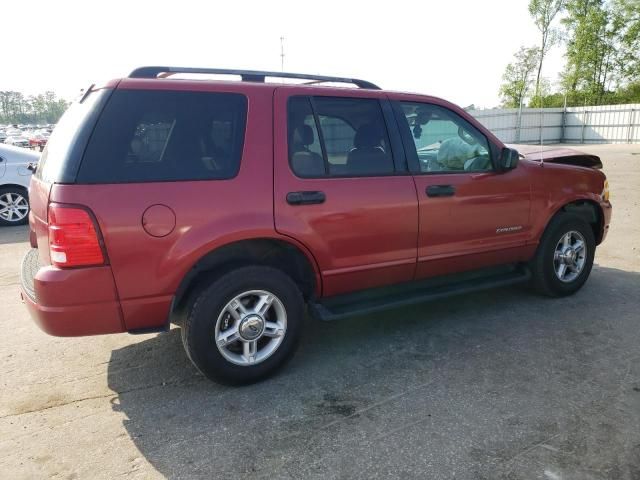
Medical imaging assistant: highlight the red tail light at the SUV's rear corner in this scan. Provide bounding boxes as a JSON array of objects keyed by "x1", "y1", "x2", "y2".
[{"x1": 49, "y1": 203, "x2": 105, "y2": 267}]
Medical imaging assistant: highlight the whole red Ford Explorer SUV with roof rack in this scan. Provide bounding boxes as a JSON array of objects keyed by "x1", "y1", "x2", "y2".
[{"x1": 22, "y1": 67, "x2": 611, "y2": 383}]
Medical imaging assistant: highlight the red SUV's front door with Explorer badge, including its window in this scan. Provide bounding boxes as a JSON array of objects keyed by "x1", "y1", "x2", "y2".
[{"x1": 393, "y1": 97, "x2": 531, "y2": 279}]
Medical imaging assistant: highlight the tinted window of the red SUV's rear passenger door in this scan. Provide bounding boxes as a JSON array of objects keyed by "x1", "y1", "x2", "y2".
[{"x1": 288, "y1": 97, "x2": 394, "y2": 177}]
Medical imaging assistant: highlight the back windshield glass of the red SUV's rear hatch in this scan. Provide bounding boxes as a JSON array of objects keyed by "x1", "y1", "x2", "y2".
[{"x1": 36, "y1": 89, "x2": 111, "y2": 183}]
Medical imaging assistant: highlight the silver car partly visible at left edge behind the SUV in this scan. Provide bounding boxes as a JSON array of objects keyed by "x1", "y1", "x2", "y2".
[{"x1": 0, "y1": 145, "x2": 40, "y2": 226}]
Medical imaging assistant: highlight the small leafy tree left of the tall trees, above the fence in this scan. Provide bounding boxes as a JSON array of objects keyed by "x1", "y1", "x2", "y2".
[{"x1": 500, "y1": 46, "x2": 540, "y2": 108}]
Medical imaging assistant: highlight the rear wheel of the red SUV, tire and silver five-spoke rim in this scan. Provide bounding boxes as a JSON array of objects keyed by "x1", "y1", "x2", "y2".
[{"x1": 182, "y1": 266, "x2": 304, "y2": 385}]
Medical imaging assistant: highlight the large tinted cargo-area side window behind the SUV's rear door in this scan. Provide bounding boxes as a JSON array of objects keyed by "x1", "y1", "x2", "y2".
[{"x1": 77, "y1": 90, "x2": 247, "y2": 183}]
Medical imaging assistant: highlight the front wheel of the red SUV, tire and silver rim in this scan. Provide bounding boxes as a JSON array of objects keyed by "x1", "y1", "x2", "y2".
[{"x1": 530, "y1": 212, "x2": 596, "y2": 297}]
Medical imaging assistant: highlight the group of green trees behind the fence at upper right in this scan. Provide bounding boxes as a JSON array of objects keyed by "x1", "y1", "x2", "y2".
[{"x1": 500, "y1": 0, "x2": 640, "y2": 107}]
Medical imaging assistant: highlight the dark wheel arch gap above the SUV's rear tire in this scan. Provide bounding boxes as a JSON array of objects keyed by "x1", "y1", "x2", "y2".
[{"x1": 170, "y1": 237, "x2": 321, "y2": 322}]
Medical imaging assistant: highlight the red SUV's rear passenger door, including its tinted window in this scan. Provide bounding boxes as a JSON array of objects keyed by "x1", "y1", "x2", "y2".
[{"x1": 274, "y1": 87, "x2": 418, "y2": 296}]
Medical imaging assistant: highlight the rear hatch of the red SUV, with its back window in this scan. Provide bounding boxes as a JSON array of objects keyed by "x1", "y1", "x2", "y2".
[{"x1": 29, "y1": 82, "x2": 116, "y2": 265}]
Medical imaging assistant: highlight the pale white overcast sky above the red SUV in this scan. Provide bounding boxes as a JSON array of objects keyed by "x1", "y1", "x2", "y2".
[{"x1": 0, "y1": 0, "x2": 563, "y2": 108}]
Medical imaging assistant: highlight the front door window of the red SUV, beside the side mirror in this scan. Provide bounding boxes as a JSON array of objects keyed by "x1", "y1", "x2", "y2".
[{"x1": 400, "y1": 102, "x2": 493, "y2": 173}]
